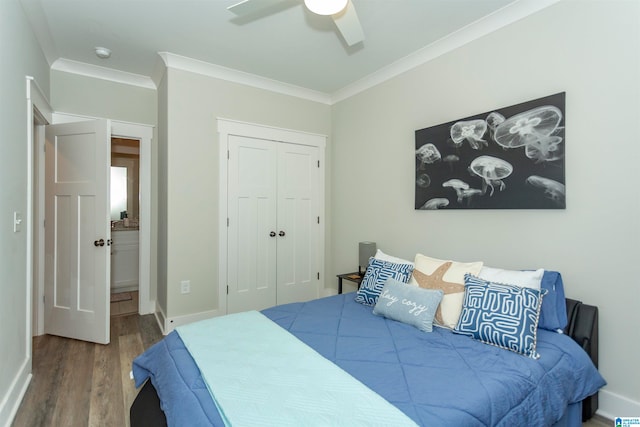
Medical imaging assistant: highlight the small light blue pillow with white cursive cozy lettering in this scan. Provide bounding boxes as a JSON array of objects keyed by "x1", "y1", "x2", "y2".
[{"x1": 373, "y1": 279, "x2": 444, "y2": 332}]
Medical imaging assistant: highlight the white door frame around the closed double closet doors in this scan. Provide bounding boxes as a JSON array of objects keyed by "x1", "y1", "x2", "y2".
[{"x1": 217, "y1": 117, "x2": 327, "y2": 315}]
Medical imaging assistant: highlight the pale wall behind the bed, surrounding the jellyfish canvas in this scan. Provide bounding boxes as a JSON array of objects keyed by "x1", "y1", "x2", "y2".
[{"x1": 331, "y1": 1, "x2": 640, "y2": 416}]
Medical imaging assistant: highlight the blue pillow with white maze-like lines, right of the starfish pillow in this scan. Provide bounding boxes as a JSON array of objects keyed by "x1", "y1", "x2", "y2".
[{"x1": 454, "y1": 274, "x2": 546, "y2": 359}]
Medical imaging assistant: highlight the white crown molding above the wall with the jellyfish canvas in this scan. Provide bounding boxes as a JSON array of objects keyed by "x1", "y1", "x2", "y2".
[{"x1": 330, "y1": 0, "x2": 560, "y2": 105}]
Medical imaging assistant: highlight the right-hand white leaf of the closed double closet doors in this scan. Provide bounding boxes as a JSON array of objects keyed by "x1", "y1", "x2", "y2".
[{"x1": 277, "y1": 143, "x2": 320, "y2": 304}]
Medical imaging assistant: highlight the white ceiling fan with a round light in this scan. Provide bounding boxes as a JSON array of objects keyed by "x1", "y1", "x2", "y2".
[{"x1": 227, "y1": 0, "x2": 364, "y2": 46}]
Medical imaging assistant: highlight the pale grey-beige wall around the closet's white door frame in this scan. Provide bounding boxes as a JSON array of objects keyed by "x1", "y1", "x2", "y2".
[{"x1": 158, "y1": 68, "x2": 331, "y2": 319}]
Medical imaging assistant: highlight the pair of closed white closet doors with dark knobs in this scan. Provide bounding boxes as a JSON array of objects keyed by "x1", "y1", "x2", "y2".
[{"x1": 227, "y1": 136, "x2": 320, "y2": 313}]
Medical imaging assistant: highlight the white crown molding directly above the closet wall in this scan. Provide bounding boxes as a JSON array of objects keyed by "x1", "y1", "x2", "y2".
[{"x1": 158, "y1": 52, "x2": 331, "y2": 104}]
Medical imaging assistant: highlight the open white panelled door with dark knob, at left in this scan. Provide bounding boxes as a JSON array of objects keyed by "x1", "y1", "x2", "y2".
[{"x1": 44, "y1": 120, "x2": 111, "y2": 344}]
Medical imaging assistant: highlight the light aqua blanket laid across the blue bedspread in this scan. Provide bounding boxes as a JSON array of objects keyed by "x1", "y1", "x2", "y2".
[{"x1": 176, "y1": 311, "x2": 416, "y2": 427}]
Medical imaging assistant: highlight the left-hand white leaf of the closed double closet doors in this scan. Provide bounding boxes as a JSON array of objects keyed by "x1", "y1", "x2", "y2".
[{"x1": 227, "y1": 136, "x2": 277, "y2": 313}]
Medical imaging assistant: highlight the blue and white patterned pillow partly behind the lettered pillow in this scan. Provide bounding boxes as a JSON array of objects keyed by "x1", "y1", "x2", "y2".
[{"x1": 356, "y1": 258, "x2": 413, "y2": 305}]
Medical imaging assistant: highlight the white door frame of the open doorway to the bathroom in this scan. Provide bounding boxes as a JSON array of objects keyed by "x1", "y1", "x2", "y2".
[{"x1": 32, "y1": 112, "x2": 156, "y2": 336}]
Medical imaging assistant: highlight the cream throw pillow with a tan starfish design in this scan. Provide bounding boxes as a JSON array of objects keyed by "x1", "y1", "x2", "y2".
[{"x1": 410, "y1": 254, "x2": 482, "y2": 329}]
